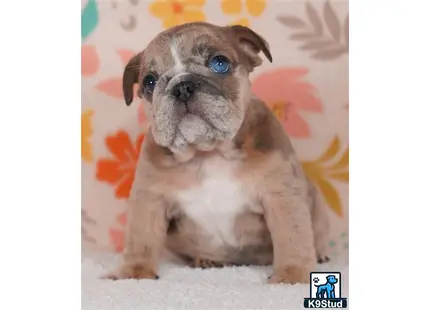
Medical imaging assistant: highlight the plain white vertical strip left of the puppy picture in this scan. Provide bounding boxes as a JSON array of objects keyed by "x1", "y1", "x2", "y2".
[{"x1": 0, "y1": 0, "x2": 81, "y2": 310}]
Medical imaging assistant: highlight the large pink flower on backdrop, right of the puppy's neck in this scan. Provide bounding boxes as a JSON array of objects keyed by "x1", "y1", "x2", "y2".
[{"x1": 252, "y1": 68, "x2": 322, "y2": 138}]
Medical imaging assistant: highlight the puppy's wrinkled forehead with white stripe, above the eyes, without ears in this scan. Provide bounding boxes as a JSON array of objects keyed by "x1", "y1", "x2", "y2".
[{"x1": 143, "y1": 23, "x2": 238, "y2": 73}]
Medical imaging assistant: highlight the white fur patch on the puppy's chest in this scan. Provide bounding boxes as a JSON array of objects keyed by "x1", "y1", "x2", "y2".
[{"x1": 176, "y1": 158, "x2": 248, "y2": 246}]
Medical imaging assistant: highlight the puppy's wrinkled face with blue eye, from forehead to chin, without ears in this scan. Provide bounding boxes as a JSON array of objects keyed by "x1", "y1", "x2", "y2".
[{"x1": 122, "y1": 23, "x2": 270, "y2": 150}]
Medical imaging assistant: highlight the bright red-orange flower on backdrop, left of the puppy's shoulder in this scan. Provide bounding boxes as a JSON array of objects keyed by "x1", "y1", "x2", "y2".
[{"x1": 96, "y1": 130, "x2": 144, "y2": 199}]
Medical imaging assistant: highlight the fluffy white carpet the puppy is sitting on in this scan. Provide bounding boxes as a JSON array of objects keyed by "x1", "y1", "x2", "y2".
[{"x1": 82, "y1": 253, "x2": 348, "y2": 310}]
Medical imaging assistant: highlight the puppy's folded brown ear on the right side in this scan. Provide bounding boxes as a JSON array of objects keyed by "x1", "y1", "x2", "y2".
[{"x1": 229, "y1": 25, "x2": 272, "y2": 68}]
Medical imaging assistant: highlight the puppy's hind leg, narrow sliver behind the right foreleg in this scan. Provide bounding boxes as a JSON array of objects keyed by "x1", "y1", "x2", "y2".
[{"x1": 309, "y1": 181, "x2": 330, "y2": 264}]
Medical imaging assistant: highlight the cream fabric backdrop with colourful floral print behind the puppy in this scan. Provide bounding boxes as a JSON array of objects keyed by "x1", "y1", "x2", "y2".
[{"x1": 81, "y1": 0, "x2": 349, "y2": 257}]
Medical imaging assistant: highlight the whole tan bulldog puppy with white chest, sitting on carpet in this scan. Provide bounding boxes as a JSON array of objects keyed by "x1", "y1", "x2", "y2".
[{"x1": 108, "y1": 23, "x2": 328, "y2": 283}]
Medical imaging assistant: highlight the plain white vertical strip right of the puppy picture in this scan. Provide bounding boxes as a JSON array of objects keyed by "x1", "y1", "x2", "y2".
[{"x1": 348, "y1": 0, "x2": 430, "y2": 310}]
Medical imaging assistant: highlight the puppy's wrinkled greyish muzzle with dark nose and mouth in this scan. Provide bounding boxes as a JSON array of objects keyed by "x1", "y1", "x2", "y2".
[{"x1": 153, "y1": 73, "x2": 242, "y2": 149}]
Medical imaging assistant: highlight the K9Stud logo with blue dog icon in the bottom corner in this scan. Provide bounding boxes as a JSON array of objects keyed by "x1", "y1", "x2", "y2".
[{"x1": 304, "y1": 272, "x2": 347, "y2": 308}]
